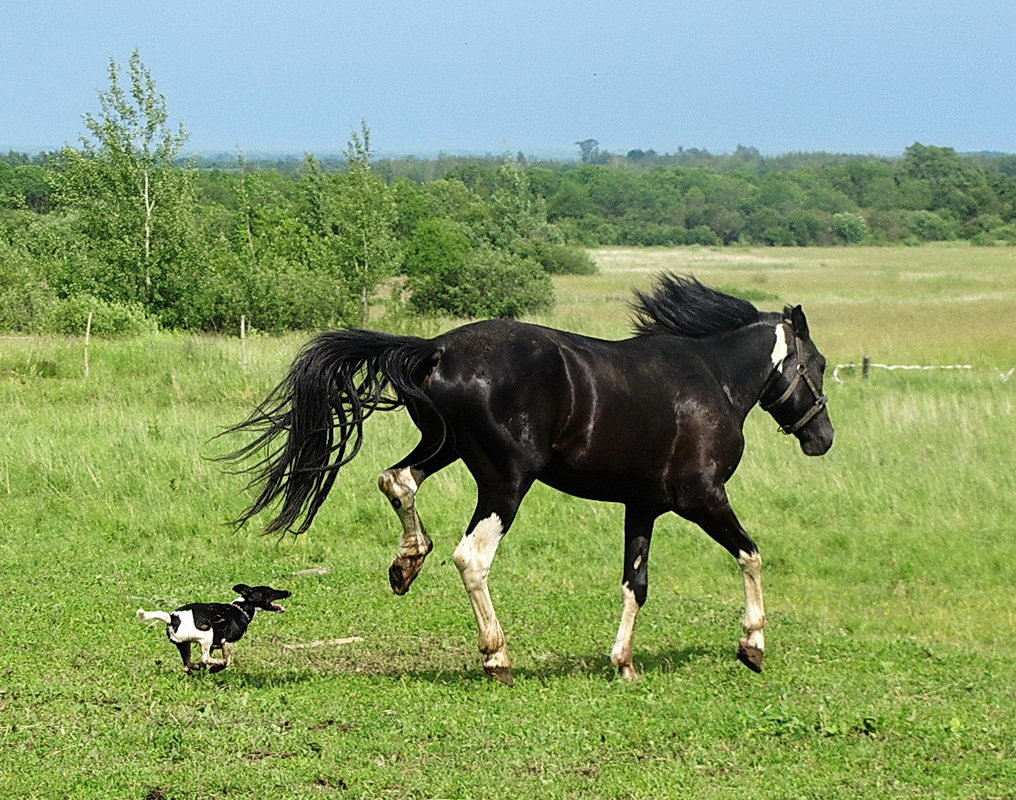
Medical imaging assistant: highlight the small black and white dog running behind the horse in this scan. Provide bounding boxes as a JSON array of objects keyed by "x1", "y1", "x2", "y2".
[{"x1": 137, "y1": 583, "x2": 290, "y2": 673}]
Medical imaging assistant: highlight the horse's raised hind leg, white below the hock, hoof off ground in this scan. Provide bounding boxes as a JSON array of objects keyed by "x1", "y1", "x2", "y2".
[{"x1": 378, "y1": 424, "x2": 456, "y2": 595}]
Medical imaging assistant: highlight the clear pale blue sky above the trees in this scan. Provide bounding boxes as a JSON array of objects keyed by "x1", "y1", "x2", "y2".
[{"x1": 0, "y1": 0, "x2": 1016, "y2": 155}]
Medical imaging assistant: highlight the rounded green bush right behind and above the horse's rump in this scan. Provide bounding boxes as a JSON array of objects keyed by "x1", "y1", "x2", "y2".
[{"x1": 409, "y1": 247, "x2": 554, "y2": 318}]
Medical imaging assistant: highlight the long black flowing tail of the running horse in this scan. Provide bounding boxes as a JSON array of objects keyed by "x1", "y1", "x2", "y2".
[{"x1": 224, "y1": 329, "x2": 435, "y2": 534}]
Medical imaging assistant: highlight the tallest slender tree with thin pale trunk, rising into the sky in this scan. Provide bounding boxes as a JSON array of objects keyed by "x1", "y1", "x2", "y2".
[{"x1": 54, "y1": 50, "x2": 193, "y2": 310}]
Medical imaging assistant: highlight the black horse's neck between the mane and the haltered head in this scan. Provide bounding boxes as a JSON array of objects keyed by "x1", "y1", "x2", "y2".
[{"x1": 700, "y1": 321, "x2": 777, "y2": 416}]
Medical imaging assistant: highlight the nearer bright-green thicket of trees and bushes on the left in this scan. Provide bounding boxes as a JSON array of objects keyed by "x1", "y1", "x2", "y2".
[{"x1": 0, "y1": 52, "x2": 594, "y2": 333}]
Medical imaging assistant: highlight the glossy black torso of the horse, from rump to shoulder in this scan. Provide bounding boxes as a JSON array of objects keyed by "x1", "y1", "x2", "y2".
[{"x1": 416, "y1": 320, "x2": 740, "y2": 503}]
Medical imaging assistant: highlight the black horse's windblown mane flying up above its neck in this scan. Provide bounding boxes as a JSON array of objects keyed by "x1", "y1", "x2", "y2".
[{"x1": 631, "y1": 272, "x2": 760, "y2": 339}]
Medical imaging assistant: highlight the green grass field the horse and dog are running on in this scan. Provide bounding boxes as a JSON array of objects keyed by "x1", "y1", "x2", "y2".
[{"x1": 0, "y1": 247, "x2": 1016, "y2": 800}]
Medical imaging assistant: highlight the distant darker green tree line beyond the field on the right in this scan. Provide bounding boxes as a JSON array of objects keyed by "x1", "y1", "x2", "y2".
[{"x1": 402, "y1": 140, "x2": 1016, "y2": 246}]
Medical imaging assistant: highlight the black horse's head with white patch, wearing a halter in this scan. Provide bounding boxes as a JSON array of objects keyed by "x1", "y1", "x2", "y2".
[{"x1": 761, "y1": 306, "x2": 833, "y2": 455}]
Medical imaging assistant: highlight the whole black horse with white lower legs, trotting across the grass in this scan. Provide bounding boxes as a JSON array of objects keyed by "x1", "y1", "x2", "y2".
[{"x1": 227, "y1": 274, "x2": 833, "y2": 683}]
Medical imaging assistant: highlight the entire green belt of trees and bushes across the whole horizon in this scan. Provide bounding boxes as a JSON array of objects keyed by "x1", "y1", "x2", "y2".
[{"x1": 0, "y1": 52, "x2": 1016, "y2": 334}]
